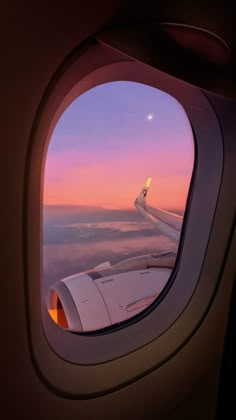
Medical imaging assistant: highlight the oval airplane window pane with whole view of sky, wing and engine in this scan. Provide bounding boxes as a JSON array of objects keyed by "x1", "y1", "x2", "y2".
[{"x1": 43, "y1": 81, "x2": 194, "y2": 333}]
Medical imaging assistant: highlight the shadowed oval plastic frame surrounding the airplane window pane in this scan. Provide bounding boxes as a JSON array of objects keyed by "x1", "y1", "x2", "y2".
[{"x1": 24, "y1": 42, "x2": 223, "y2": 398}]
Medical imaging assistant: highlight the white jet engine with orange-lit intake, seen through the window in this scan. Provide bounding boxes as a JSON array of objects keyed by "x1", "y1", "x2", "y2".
[{"x1": 48, "y1": 252, "x2": 176, "y2": 332}]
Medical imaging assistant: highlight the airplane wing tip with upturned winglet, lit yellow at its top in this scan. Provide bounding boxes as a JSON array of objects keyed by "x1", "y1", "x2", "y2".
[{"x1": 134, "y1": 178, "x2": 183, "y2": 242}]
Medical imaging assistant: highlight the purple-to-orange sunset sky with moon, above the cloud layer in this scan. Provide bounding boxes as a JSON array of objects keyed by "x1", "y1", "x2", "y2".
[{"x1": 44, "y1": 82, "x2": 194, "y2": 209}]
